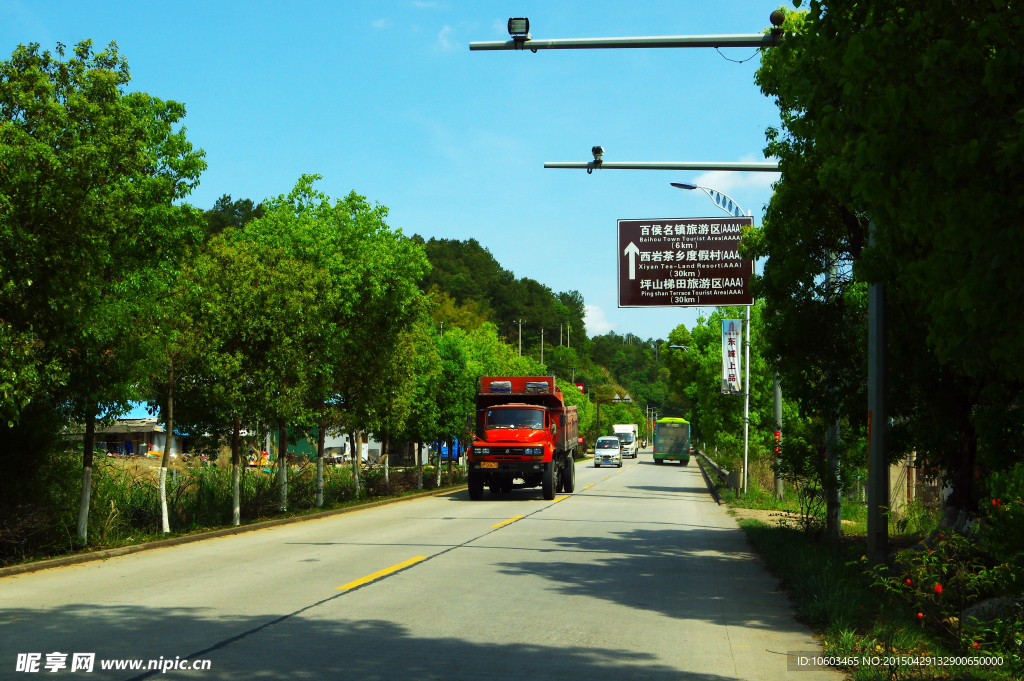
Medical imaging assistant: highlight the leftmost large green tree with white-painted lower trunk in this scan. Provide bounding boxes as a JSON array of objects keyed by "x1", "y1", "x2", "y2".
[{"x1": 0, "y1": 41, "x2": 205, "y2": 542}]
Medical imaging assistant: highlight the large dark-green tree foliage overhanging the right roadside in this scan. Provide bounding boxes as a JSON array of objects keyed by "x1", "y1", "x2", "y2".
[{"x1": 751, "y1": 1, "x2": 1024, "y2": 508}]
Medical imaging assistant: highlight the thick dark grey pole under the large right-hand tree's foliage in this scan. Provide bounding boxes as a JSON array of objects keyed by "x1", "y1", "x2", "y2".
[{"x1": 867, "y1": 222, "x2": 889, "y2": 565}]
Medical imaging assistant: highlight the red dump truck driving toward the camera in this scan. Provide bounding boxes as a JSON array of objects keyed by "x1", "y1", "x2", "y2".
[{"x1": 468, "y1": 376, "x2": 580, "y2": 501}]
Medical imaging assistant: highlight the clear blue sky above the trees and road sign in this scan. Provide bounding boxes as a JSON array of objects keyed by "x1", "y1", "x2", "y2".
[{"x1": 0, "y1": 0, "x2": 778, "y2": 338}]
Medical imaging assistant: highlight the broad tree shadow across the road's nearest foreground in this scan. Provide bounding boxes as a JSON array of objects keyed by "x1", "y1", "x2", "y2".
[{"x1": 0, "y1": 595, "x2": 732, "y2": 681}]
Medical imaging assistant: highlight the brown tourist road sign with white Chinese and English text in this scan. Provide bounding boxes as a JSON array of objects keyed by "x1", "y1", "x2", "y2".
[{"x1": 617, "y1": 217, "x2": 754, "y2": 307}]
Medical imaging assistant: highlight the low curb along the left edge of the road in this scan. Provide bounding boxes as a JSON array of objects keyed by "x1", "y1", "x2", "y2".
[{"x1": 0, "y1": 484, "x2": 466, "y2": 578}]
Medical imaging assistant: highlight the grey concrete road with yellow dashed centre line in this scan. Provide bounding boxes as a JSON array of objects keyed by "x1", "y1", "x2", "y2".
[{"x1": 0, "y1": 448, "x2": 839, "y2": 681}]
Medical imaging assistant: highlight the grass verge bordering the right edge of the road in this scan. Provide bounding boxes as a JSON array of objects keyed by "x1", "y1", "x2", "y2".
[{"x1": 739, "y1": 519, "x2": 1017, "y2": 681}]
